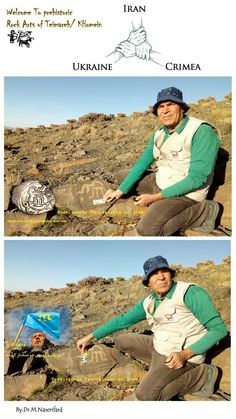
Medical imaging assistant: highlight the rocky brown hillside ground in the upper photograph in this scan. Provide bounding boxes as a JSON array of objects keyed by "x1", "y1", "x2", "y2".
[{"x1": 5, "y1": 94, "x2": 231, "y2": 236}]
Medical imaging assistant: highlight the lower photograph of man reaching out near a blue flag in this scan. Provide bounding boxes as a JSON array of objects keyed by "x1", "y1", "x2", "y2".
[{"x1": 4, "y1": 238, "x2": 231, "y2": 402}]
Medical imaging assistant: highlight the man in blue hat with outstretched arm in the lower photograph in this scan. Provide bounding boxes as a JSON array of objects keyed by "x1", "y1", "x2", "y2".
[{"x1": 77, "y1": 256, "x2": 227, "y2": 401}]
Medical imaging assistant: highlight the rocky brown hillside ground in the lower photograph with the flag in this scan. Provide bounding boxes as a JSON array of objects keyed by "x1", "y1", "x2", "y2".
[{"x1": 5, "y1": 257, "x2": 231, "y2": 400}]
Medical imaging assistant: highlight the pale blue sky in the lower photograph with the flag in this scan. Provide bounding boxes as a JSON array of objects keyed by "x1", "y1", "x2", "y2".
[{"x1": 5, "y1": 239, "x2": 230, "y2": 291}]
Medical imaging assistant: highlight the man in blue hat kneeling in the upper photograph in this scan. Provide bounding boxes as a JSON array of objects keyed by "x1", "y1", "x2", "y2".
[{"x1": 104, "y1": 87, "x2": 220, "y2": 236}]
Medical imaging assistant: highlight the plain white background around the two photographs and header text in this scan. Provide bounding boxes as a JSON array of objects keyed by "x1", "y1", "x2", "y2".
[{"x1": 0, "y1": 0, "x2": 235, "y2": 418}]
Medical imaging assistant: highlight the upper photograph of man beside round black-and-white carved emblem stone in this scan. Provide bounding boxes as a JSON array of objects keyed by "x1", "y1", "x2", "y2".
[{"x1": 4, "y1": 77, "x2": 232, "y2": 237}]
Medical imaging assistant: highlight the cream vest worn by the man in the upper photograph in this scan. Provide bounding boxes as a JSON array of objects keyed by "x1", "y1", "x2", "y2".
[{"x1": 153, "y1": 117, "x2": 217, "y2": 202}]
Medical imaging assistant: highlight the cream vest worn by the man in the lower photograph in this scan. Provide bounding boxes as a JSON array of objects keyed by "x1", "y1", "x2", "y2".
[{"x1": 143, "y1": 281, "x2": 207, "y2": 364}]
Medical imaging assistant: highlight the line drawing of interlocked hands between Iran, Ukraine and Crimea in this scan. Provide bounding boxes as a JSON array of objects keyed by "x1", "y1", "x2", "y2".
[{"x1": 108, "y1": 21, "x2": 162, "y2": 66}]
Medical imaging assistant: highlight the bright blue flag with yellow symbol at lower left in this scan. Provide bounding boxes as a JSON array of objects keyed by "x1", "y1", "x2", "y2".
[{"x1": 23, "y1": 311, "x2": 61, "y2": 340}]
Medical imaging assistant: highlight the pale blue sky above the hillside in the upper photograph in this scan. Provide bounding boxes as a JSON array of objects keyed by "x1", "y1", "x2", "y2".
[{"x1": 4, "y1": 77, "x2": 231, "y2": 128}]
